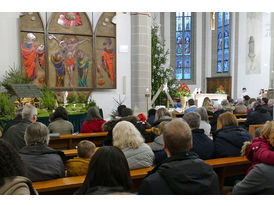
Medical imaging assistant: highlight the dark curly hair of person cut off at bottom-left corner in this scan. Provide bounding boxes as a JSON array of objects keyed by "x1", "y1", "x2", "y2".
[{"x1": 0, "y1": 139, "x2": 26, "y2": 187}]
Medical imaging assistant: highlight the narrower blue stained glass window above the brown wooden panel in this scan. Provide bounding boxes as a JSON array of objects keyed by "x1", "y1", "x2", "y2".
[{"x1": 217, "y1": 12, "x2": 230, "y2": 73}]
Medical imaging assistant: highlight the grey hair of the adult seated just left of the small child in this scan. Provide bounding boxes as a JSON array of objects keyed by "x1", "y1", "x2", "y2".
[{"x1": 24, "y1": 122, "x2": 49, "y2": 145}]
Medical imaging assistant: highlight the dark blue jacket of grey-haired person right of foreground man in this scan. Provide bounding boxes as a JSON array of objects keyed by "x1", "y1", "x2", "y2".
[{"x1": 190, "y1": 129, "x2": 214, "y2": 160}]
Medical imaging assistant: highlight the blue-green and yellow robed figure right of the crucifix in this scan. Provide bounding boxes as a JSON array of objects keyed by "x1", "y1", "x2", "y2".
[{"x1": 76, "y1": 49, "x2": 90, "y2": 87}]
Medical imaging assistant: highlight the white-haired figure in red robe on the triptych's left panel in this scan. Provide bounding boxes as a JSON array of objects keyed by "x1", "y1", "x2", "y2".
[{"x1": 21, "y1": 33, "x2": 45, "y2": 81}]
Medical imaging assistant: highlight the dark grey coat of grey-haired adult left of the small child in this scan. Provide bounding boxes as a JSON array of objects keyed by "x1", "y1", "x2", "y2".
[{"x1": 19, "y1": 144, "x2": 65, "y2": 182}]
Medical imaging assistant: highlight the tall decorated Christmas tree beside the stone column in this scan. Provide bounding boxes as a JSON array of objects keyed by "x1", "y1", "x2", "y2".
[{"x1": 151, "y1": 24, "x2": 178, "y2": 105}]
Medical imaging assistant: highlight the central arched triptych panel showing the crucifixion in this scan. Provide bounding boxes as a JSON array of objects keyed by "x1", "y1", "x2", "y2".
[{"x1": 48, "y1": 12, "x2": 94, "y2": 90}]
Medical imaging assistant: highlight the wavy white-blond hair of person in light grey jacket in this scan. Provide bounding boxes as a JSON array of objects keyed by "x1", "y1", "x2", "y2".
[{"x1": 112, "y1": 121, "x2": 144, "y2": 149}]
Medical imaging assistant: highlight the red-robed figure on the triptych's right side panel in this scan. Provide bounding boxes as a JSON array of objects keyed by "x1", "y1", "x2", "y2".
[{"x1": 97, "y1": 38, "x2": 115, "y2": 85}]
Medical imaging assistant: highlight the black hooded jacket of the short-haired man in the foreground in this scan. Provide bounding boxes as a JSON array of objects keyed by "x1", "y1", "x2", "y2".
[{"x1": 139, "y1": 152, "x2": 219, "y2": 195}]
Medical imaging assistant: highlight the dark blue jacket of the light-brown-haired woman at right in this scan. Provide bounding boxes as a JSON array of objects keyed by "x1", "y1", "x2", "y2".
[{"x1": 213, "y1": 126, "x2": 252, "y2": 158}]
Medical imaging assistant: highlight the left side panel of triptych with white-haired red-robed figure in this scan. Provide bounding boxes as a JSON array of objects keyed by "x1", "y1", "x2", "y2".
[{"x1": 20, "y1": 12, "x2": 46, "y2": 87}]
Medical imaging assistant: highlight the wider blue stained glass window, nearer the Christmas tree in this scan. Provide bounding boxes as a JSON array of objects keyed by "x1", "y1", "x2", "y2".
[{"x1": 176, "y1": 12, "x2": 193, "y2": 80}]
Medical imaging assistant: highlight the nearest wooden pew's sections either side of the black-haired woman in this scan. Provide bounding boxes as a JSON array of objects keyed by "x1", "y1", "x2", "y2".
[{"x1": 32, "y1": 167, "x2": 153, "y2": 195}]
